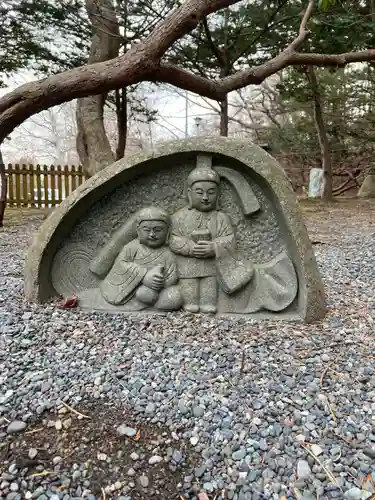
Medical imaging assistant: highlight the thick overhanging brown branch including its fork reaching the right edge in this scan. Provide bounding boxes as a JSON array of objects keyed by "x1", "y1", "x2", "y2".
[{"x1": 0, "y1": 0, "x2": 375, "y2": 143}]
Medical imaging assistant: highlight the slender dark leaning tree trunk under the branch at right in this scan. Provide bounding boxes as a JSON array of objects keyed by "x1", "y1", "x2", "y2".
[{"x1": 308, "y1": 66, "x2": 333, "y2": 201}]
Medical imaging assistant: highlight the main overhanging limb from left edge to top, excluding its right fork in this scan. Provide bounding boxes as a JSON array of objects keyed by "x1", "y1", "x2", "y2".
[{"x1": 0, "y1": 0, "x2": 240, "y2": 143}]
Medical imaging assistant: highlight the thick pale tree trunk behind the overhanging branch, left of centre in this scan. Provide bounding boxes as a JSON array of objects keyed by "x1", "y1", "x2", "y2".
[{"x1": 76, "y1": 0, "x2": 120, "y2": 177}]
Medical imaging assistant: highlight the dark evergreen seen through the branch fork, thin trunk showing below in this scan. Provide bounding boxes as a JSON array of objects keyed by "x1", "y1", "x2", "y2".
[{"x1": 167, "y1": 0, "x2": 301, "y2": 136}]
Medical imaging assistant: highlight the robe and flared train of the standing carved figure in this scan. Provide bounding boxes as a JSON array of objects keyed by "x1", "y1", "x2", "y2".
[{"x1": 169, "y1": 207, "x2": 298, "y2": 313}]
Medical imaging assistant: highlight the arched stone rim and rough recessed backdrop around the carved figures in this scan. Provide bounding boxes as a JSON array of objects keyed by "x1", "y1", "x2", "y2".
[{"x1": 25, "y1": 138, "x2": 325, "y2": 321}]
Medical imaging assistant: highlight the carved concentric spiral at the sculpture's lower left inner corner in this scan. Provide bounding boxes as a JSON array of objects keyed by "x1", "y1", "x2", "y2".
[{"x1": 52, "y1": 244, "x2": 99, "y2": 296}]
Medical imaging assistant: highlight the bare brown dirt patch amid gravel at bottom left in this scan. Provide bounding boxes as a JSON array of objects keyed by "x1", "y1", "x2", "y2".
[{"x1": 0, "y1": 402, "x2": 200, "y2": 500}]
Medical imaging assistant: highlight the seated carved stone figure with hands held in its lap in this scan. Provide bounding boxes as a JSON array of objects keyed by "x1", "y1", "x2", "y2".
[{"x1": 100, "y1": 207, "x2": 182, "y2": 311}]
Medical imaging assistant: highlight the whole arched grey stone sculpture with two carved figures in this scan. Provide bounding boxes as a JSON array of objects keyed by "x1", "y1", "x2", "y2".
[{"x1": 26, "y1": 138, "x2": 325, "y2": 321}]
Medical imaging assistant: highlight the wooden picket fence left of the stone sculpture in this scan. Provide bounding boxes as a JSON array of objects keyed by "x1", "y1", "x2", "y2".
[{"x1": 6, "y1": 164, "x2": 86, "y2": 208}]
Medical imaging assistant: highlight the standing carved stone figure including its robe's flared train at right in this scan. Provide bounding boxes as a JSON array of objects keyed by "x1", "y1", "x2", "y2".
[{"x1": 169, "y1": 158, "x2": 298, "y2": 313}]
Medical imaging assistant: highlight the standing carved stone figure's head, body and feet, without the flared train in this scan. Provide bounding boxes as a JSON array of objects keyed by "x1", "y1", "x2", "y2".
[{"x1": 169, "y1": 166, "x2": 235, "y2": 313}]
